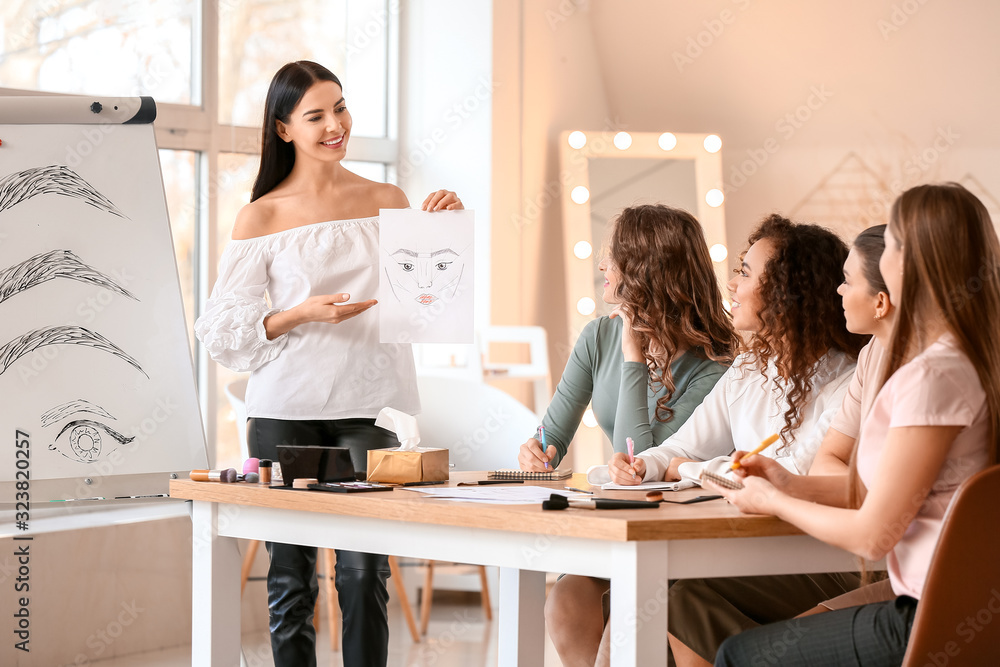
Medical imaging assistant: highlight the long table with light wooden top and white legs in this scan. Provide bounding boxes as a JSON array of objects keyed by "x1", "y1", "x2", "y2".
[{"x1": 170, "y1": 473, "x2": 857, "y2": 667}]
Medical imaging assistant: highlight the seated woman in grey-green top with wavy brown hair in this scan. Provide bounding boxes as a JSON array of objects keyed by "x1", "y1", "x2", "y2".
[{"x1": 518, "y1": 205, "x2": 738, "y2": 470}]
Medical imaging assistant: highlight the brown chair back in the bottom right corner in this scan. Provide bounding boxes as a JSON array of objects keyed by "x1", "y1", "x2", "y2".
[{"x1": 903, "y1": 465, "x2": 1000, "y2": 667}]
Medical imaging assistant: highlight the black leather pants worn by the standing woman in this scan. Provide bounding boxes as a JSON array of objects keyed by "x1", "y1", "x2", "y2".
[{"x1": 247, "y1": 418, "x2": 399, "y2": 667}]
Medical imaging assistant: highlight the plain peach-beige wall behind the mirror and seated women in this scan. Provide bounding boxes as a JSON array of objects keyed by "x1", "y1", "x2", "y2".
[{"x1": 492, "y1": 0, "x2": 1000, "y2": 469}]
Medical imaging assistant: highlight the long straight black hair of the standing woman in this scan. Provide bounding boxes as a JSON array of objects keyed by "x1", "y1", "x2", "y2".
[{"x1": 250, "y1": 60, "x2": 343, "y2": 201}]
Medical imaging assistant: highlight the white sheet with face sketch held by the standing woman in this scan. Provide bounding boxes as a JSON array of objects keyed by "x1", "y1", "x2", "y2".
[{"x1": 377, "y1": 209, "x2": 475, "y2": 343}]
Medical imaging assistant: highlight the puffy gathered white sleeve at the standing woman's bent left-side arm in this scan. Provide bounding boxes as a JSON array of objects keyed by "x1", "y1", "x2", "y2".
[{"x1": 194, "y1": 241, "x2": 288, "y2": 372}]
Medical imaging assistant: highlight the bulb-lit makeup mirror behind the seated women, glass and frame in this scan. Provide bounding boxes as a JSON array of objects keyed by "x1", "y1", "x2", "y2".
[{"x1": 560, "y1": 130, "x2": 729, "y2": 470}]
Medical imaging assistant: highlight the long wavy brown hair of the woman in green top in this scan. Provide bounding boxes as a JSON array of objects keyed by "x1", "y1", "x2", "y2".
[{"x1": 608, "y1": 204, "x2": 739, "y2": 422}]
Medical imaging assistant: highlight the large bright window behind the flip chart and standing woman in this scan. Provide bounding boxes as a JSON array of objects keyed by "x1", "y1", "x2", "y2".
[{"x1": 0, "y1": 0, "x2": 399, "y2": 466}]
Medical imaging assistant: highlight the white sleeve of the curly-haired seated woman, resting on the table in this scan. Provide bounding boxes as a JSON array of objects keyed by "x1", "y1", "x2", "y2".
[{"x1": 638, "y1": 357, "x2": 747, "y2": 481}]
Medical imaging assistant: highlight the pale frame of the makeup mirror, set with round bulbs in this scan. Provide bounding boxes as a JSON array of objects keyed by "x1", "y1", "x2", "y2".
[{"x1": 559, "y1": 130, "x2": 729, "y2": 470}]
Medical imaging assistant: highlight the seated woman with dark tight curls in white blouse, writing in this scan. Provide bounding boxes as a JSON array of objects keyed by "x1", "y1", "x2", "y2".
[{"x1": 601, "y1": 215, "x2": 867, "y2": 659}]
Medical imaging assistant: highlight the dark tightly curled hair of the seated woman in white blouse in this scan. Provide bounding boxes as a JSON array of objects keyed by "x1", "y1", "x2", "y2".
[{"x1": 744, "y1": 214, "x2": 869, "y2": 446}]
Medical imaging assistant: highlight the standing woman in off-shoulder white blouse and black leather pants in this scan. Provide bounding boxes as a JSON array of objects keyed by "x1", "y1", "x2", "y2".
[{"x1": 195, "y1": 61, "x2": 463, "y2": 667}]
